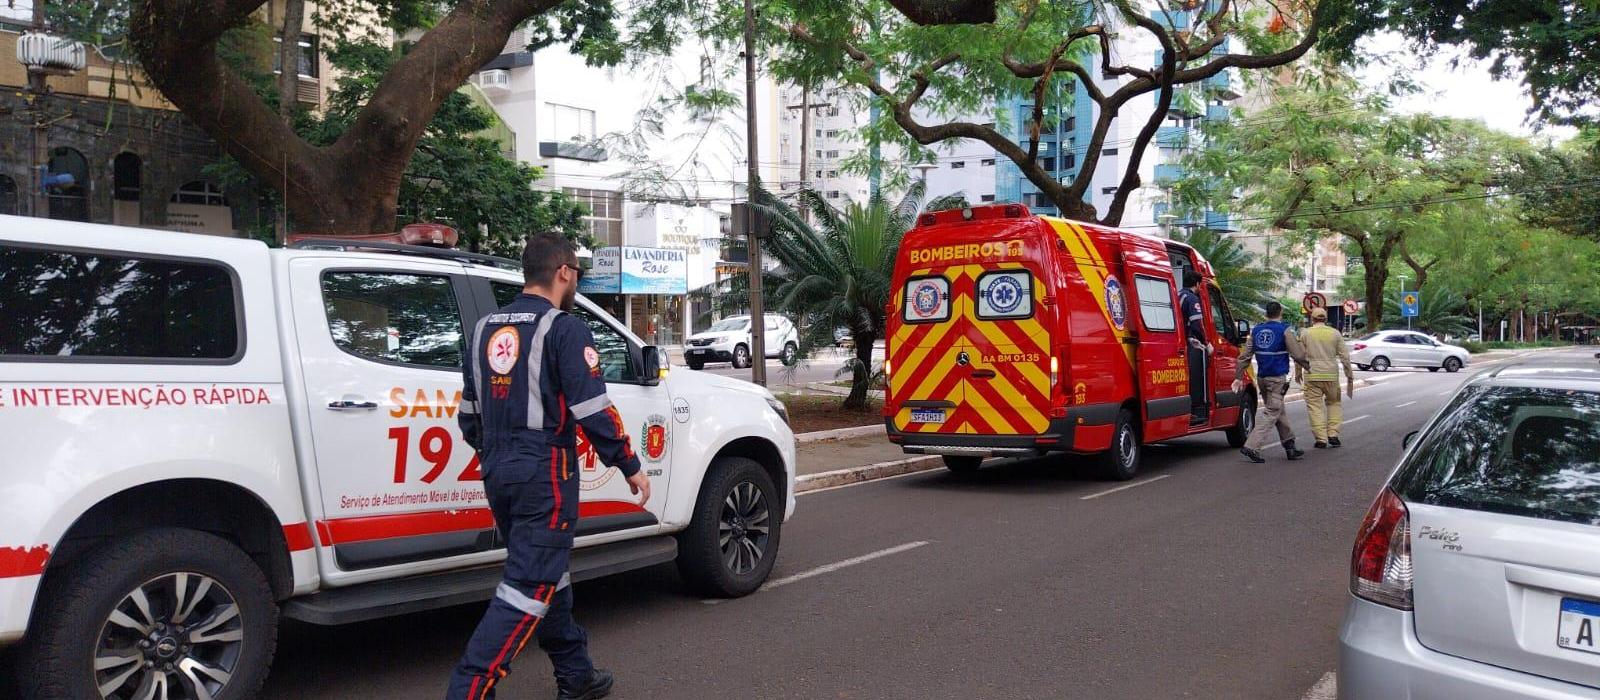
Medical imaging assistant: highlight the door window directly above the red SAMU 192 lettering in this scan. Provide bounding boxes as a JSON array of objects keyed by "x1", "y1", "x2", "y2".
[{"x1": 322, "y1": 270, "x2": 461, "y2": 371}]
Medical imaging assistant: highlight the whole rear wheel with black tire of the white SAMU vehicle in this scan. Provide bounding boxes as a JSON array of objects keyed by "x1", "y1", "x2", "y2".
[{"x1": 18, "y1": 529, "x2": 278, "y2": 700}]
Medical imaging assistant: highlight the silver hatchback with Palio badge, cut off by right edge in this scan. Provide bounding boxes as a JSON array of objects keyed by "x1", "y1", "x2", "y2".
[{"x1": 1338, "y1": 353, "x2": 1600, "y2": 700}]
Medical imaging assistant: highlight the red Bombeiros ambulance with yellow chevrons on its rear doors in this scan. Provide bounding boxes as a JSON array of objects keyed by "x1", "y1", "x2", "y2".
[{"x1": 883, "y1": 205, "x2": 1256, "y2": 479}]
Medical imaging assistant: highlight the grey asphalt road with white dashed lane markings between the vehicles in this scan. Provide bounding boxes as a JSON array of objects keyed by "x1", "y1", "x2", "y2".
[{"x1": 246, "y1": 353, "x2": 1548, "y2": 700}]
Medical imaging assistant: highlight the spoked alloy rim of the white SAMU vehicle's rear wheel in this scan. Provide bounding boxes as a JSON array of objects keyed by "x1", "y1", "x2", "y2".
[{"x1": 93, "y1": 572, "x2": 245, "y2": 700}]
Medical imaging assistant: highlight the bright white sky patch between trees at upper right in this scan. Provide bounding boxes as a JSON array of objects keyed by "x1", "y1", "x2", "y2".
[{"x1": 1362, "y1": 32, "x2": 1576, "y2": 139}]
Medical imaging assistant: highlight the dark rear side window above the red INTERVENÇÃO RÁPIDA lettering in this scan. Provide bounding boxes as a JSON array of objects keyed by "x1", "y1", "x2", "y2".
[{"x1": 0, "y1": 245, "x2": 243, "y2": 363}]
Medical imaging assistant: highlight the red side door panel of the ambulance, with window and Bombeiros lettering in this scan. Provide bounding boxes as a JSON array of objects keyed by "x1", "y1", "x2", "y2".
[{"x1": 1123, "y1": 247, "x2": 1189, "y2": 443}]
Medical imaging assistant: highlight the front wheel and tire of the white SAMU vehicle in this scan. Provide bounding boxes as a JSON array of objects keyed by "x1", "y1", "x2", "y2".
[{"x1": 678, "y1": 457, "x2": 784, "y2": 598}]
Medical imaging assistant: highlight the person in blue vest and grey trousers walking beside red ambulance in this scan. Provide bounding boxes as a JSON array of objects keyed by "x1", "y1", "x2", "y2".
[{"x1": 1234, "y1": 302, "x2": 1306, "y2": 463}]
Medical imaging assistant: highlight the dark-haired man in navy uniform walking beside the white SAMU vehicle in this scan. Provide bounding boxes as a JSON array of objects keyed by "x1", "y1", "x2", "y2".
[{"x1": 446, "y1": 233, "x2": 650, "y2": 700}]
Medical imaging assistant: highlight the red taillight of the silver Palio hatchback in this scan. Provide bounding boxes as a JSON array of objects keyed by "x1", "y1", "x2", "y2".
[{"x1": 1350, "y1": 489, "x2": 1411, "y2": 611}]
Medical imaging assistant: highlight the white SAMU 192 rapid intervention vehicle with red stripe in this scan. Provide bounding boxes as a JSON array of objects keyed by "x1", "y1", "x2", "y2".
[{"x1": 0, "y1": 216, "x2": 795, "y2": 700}]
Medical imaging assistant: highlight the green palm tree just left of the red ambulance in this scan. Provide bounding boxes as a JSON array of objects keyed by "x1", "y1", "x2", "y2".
[{"x1": 736, "y1": 182, "x2": 925, "y2": 409}]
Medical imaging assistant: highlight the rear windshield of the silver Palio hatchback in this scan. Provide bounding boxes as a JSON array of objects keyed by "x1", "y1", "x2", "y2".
[{"x1": 1395, "y1": 387, "x2": 1600, "y2": 524}]
